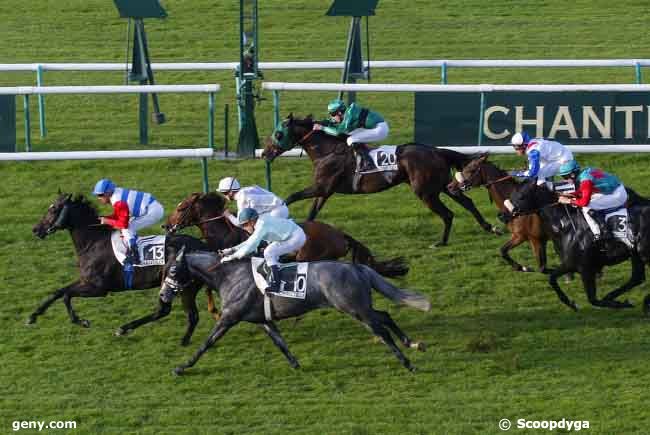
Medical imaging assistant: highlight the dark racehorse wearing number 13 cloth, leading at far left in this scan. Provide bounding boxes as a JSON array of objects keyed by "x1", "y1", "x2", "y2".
[{"x1": 27, "y1": 193, "x2": 208, "y2": 344}]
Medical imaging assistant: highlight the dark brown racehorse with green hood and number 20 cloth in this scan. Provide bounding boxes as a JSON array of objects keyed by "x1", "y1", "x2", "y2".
[{"x1": 263, "y1": 115, "x2": 499, "y2": 246}]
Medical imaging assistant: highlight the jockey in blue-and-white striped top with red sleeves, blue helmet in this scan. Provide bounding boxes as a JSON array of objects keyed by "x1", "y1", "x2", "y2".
[{"x1": 93, "y1": 178, "x2": 165, "y2": 264}]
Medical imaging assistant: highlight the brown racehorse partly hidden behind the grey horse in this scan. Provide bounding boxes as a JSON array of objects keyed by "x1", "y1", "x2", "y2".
[{"x1": 115, "y1": 192, "x2": 409, "y2": 335}]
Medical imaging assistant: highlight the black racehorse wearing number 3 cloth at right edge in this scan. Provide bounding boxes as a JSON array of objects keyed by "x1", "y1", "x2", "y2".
[{"x1": 511, "y1": 183, "x2": 650, "y2": 313}]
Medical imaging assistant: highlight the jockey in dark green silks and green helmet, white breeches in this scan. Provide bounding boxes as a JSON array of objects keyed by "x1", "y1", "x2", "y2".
[{"x1": 313, "y1": 100, "x2": 389, "y2": 172}]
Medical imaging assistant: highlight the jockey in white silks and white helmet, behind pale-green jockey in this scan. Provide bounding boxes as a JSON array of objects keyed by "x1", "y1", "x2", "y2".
[{"x1": 217, "y1": 177, "x2": 289, "y2": 227}]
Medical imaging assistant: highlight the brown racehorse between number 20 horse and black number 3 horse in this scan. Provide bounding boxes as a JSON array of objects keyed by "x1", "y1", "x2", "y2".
[{"x1": 448, "y1": 154, "x2": 549, "y2": 273}]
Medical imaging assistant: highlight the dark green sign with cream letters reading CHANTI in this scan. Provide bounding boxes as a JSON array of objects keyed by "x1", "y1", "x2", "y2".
[{"x1": 415, "y1": 92, "x2": 650, "y2": 145}]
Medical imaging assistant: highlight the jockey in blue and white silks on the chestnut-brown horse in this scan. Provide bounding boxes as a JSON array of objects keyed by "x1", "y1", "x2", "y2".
[{"x1": 509, "y1": 131, "x2": 573, "y2": 185}]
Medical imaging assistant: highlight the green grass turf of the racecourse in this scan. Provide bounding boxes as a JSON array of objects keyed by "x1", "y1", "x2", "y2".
[{"x1": 0, "y1": 0, "x2": 650, "y2": 435}]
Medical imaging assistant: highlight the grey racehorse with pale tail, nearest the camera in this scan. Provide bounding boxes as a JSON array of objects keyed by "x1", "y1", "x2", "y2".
[{"x1": 161, "y1": 251, "x2": 431, "y2": 375}]
